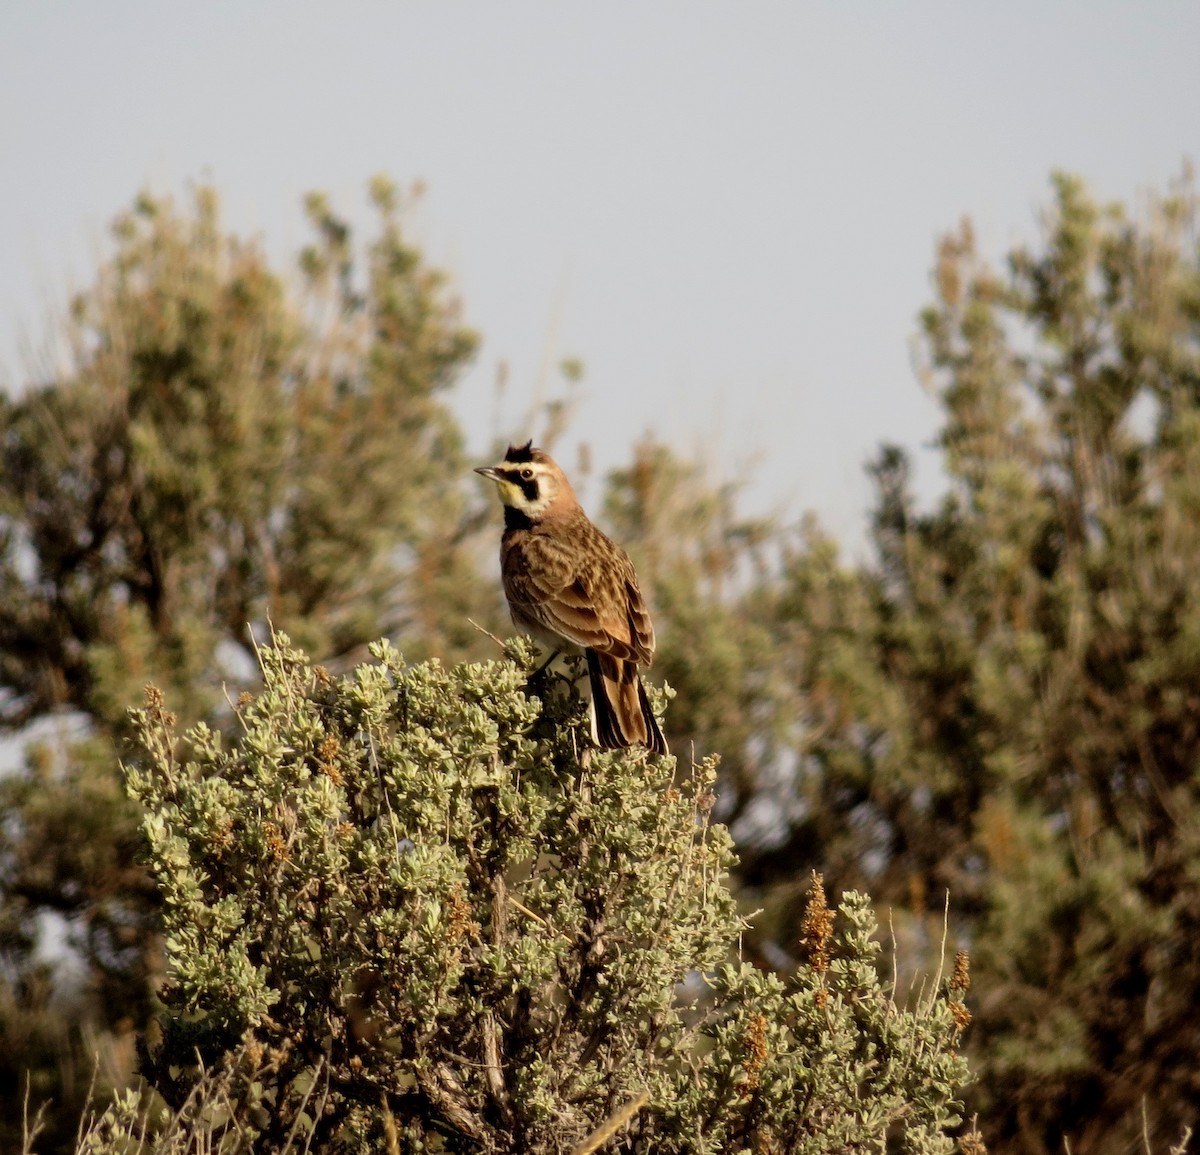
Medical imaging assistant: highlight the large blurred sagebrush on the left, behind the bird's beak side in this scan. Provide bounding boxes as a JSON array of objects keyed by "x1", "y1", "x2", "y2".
[{"x1": 0, "y1": 179, "x2": 497, "y2": 1145}]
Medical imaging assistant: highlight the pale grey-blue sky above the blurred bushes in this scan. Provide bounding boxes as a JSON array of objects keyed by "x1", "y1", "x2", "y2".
[{"x1": 0, "y1": 0, "x2": 1200, "y2": 546}]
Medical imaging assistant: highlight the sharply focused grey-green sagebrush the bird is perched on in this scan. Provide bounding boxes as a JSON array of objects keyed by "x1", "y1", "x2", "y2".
[{"x1": 93, "y1": 636, "x2": 967, "y2": 1155}]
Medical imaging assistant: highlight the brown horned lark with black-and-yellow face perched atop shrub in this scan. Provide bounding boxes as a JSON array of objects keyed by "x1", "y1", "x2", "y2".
[{"x1": 475, "y1": 442, "x2": 667, "y2": 754}]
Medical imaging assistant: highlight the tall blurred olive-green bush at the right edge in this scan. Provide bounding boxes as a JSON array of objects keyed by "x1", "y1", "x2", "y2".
[{"x1": 760, "y1": 170, "x2": 1200, "y2": 1155}]
